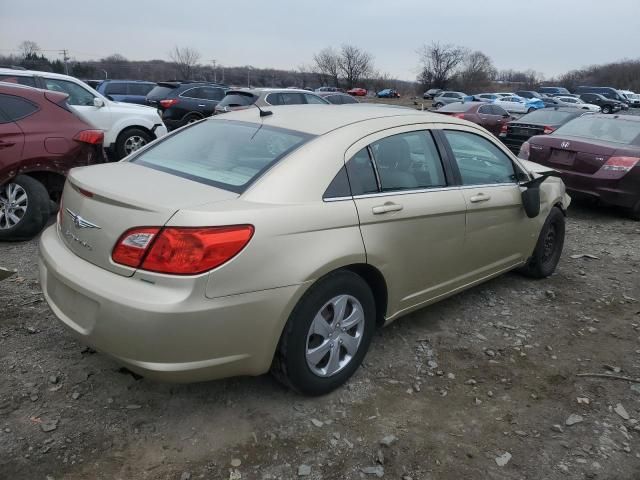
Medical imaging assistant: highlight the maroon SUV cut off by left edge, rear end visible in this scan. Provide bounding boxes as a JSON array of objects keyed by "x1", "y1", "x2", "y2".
[{"x1": 0, "y1": 82, "x2": 105, "y2": 240}]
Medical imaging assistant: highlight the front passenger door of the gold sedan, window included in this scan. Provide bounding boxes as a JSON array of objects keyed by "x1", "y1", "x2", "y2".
[{"x1": 443, "y1": 127, "x2": 537, "y2": 281}]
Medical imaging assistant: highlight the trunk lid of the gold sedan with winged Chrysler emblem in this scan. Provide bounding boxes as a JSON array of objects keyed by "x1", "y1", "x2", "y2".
[{"x1": 58, "y1": 162, "x2": 238, "y2": 276}]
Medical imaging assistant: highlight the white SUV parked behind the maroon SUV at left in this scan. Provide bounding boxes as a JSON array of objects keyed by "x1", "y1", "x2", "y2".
[{"x1": 0, "y1": 68, "x2": 167, "y2": 159}]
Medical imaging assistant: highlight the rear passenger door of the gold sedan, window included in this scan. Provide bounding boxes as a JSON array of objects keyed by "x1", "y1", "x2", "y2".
[{"x1": 346, "y1": 126, "x2": 466, "y2": 314}]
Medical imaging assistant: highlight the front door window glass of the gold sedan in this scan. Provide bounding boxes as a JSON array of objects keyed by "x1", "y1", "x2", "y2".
[{"x1": 444, "y1": 130, "x2": 516, "y2": 185}]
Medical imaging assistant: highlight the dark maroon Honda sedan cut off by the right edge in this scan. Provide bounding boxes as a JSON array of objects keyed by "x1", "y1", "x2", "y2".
[{"x1": 518, "y1": 114, "x2": 640, "y2": 220}]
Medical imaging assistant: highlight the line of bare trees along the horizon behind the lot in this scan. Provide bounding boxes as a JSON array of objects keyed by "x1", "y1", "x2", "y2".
[{"x1": 0, "y1": 40, "x2": 640, "y2": 94}]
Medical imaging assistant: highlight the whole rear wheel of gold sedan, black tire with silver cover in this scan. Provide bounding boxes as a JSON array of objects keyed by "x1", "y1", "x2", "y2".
[{"x1": 271, "y1": 270, "x2": 376, "y2": 395}]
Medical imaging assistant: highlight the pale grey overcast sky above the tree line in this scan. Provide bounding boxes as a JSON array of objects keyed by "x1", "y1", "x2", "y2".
[{"x1": 0, "y1": 0, "x2": 640, "y2": 80}]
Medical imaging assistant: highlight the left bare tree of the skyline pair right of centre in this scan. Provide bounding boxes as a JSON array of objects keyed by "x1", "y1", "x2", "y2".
[{"x1": 418, "y1": 42, "x2": 467, "y2": 88}]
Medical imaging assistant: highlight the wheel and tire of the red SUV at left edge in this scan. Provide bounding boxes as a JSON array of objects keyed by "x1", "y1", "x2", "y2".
[{"x1": 0, "y1": 175, "x2": 51, "y2": 241}]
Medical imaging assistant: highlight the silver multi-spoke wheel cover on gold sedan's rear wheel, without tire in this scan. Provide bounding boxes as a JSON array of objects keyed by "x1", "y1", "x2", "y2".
[{"x1": 305, "y1": 295, "x2": 365, "y2": 377}]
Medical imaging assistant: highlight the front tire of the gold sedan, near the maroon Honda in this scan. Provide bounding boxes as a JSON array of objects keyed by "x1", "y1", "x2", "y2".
[{"x1": 520, "y1": 207, "x2": 565, "y2": 278}]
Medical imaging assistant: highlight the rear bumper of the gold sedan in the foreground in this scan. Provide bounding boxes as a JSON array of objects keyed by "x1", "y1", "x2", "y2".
[{"x1": 39, "y1": 225, "x2": 306, "y2": 382}]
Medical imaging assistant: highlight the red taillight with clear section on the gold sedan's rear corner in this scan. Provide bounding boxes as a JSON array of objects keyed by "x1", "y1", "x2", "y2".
[{"x1": 112, "y1": 225, "x2": 254, "y2": 275}]
